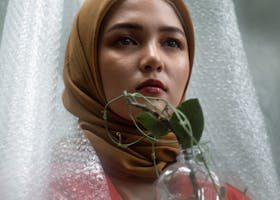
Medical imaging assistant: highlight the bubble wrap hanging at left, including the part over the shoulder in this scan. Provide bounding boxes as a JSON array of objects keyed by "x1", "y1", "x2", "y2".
[{"x1": 0, "y1": 0, "x2": 108, "y2": 200}]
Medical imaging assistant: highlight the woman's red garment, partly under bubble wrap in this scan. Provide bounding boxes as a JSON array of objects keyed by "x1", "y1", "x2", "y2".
[{"x1": 49, "y1": 165, "x2": 251, "y2": 200}]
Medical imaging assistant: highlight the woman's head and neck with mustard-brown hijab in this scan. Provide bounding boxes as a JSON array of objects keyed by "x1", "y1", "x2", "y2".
[{"x1": 59, "y1": 0, "x2": 252, "y2": 199}]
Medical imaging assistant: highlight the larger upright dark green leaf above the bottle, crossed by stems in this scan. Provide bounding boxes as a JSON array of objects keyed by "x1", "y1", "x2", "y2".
[{"x1": 170, "y1": 99, "x2": 204, "y2": 148}]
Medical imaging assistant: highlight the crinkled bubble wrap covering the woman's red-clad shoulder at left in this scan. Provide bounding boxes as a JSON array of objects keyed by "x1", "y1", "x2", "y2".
[{"x1": 48, "y1": 132, "x2": 111, "y2": 200}]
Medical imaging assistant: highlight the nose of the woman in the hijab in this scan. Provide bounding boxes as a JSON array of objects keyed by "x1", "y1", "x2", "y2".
[{"x1": 140, "y1": 42, "x2": 163, "y2": 72}]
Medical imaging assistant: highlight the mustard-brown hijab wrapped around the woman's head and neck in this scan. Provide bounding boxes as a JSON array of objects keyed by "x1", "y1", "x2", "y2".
[{"x1": 63, "y1": 0, "x2": 194, "y2": 180}]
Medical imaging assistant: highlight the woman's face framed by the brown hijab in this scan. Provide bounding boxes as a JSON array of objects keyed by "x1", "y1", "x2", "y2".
[{"x1": 98, "y1": 0, "x2": 190, "y2": 119}]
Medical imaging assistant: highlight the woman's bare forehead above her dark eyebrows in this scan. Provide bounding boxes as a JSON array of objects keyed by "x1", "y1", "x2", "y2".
[{"x1": 104, "y1": 0, "x2": 183, "y2": 30}]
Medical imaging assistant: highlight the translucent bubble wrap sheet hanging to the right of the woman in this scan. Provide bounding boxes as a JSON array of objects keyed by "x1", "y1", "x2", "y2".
[{"x1": 186, "y1": 0, "x2": 280, "y2": 200}]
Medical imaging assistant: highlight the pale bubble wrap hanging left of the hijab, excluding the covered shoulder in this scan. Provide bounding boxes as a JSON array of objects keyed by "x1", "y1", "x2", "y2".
[{"x1": 0, "y1": 0, "x2": 83, "y2": 199}]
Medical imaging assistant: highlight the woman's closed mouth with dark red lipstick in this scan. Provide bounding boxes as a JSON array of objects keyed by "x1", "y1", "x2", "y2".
[{"x1": 136, "y1": 79, "x2": 166, "y2": 96}]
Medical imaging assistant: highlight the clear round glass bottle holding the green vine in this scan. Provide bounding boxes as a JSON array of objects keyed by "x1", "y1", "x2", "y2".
[{"x1": 156, "y1": 149, "x2": 225, "y2": 200}]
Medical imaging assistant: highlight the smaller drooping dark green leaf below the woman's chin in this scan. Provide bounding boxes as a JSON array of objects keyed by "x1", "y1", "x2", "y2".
[{"x1": 136, "y1": 111, "x2": 169, "y2": 138}]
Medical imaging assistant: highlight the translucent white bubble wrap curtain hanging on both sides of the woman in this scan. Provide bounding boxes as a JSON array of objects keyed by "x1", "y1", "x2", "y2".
[{"x1": 0, "y1": 0, "x2": 280, "y2": 200}]
